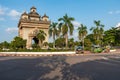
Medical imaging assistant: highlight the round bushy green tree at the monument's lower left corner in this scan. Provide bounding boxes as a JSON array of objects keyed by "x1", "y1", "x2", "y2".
[{"x1": 11, "y1": 36, "x2": 26, "y2": 49}]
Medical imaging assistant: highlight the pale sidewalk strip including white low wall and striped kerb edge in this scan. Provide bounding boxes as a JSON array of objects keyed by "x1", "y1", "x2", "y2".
[{"x1": 0, "y1": 49, "x2": 120, "y2": 57}]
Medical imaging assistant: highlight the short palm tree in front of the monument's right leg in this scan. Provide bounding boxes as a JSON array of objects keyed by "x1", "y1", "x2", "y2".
[{"x1": 36, "y1": 30, "x2": 46, "y2": 48}]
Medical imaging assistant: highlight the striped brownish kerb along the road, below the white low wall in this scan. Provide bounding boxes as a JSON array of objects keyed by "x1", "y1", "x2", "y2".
[{"x1": 0, "y1": 52, "x2": 120, "y2": 57}]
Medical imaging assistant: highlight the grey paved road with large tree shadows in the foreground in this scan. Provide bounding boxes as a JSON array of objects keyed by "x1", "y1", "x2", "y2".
[{"x1": 0, "y1": 54, "x2": 120, "y2": 80}]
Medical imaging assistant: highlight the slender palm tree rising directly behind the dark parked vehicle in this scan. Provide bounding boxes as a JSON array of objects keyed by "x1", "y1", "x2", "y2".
[{"x1": 78, "y1": 24, "x2": 87, "y2": 49}]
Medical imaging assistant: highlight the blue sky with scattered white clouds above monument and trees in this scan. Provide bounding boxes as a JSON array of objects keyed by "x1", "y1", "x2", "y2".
[{"x1": 0, "y1": 0, "x2": 120, "y2": 42}]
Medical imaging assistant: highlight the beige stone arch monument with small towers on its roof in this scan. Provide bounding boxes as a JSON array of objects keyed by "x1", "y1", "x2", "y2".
[{"x1": 18, "y1": 7, "x2": 50, "y2": 49}]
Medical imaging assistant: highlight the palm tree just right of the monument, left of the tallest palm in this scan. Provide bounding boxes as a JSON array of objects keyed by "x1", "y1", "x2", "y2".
[{"x1": 49, "y1": 22, "x2": 59, "y2": 48}]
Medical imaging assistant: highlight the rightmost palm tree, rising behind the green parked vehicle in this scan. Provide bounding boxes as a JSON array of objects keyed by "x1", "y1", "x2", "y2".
[{"x1": 90, "y1": 20, "x2": 104, "y2": 45}]
